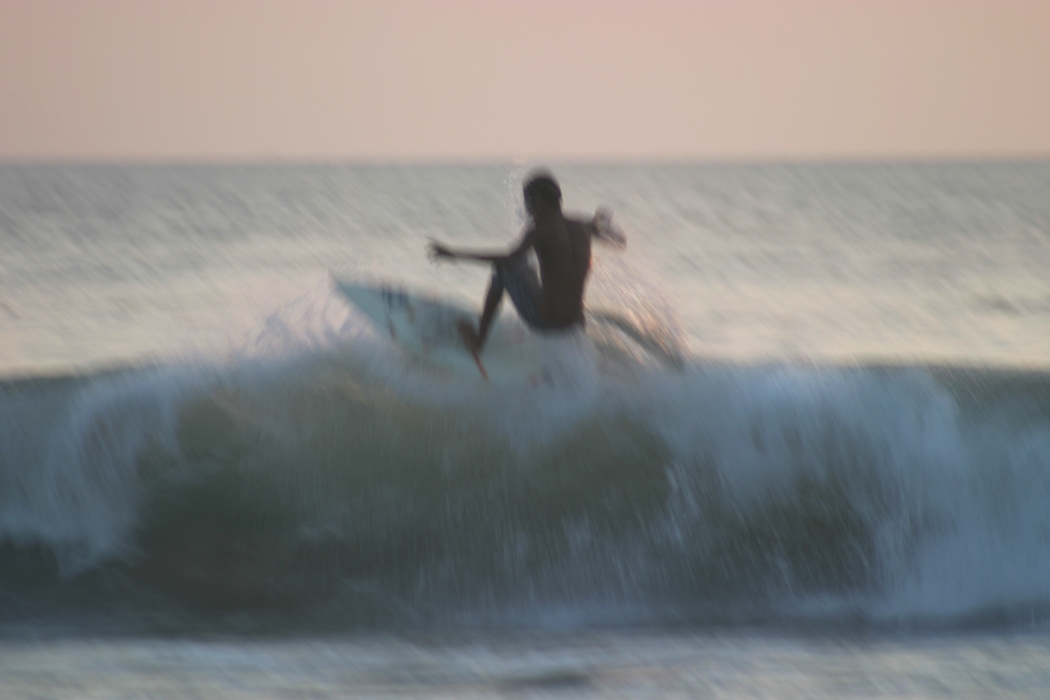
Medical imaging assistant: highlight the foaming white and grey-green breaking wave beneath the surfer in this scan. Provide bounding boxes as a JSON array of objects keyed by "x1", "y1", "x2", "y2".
[{"x1": 6, "y1": 285, "x2": 1050, "y2": 623}]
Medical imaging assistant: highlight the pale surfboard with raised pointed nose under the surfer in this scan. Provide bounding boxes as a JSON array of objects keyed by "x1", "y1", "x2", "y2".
[{"x1": 333, "y1": 276, "x2": 543, "y2": 384}]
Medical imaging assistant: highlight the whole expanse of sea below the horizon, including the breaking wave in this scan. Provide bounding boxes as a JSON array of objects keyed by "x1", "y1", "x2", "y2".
[{"x1": 0, "y1": 163, "x2": 1050, "y2": 698}]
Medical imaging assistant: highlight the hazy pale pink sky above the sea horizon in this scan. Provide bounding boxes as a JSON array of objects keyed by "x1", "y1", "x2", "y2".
[{"x1": 0, "y1": 0, "x2": 1050, "y2": 161}]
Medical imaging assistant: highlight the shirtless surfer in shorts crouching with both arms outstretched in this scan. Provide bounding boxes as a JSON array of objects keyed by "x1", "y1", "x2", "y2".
[{"x1": 429, "y1": 171, "x2": 626, "y2": 354}]
